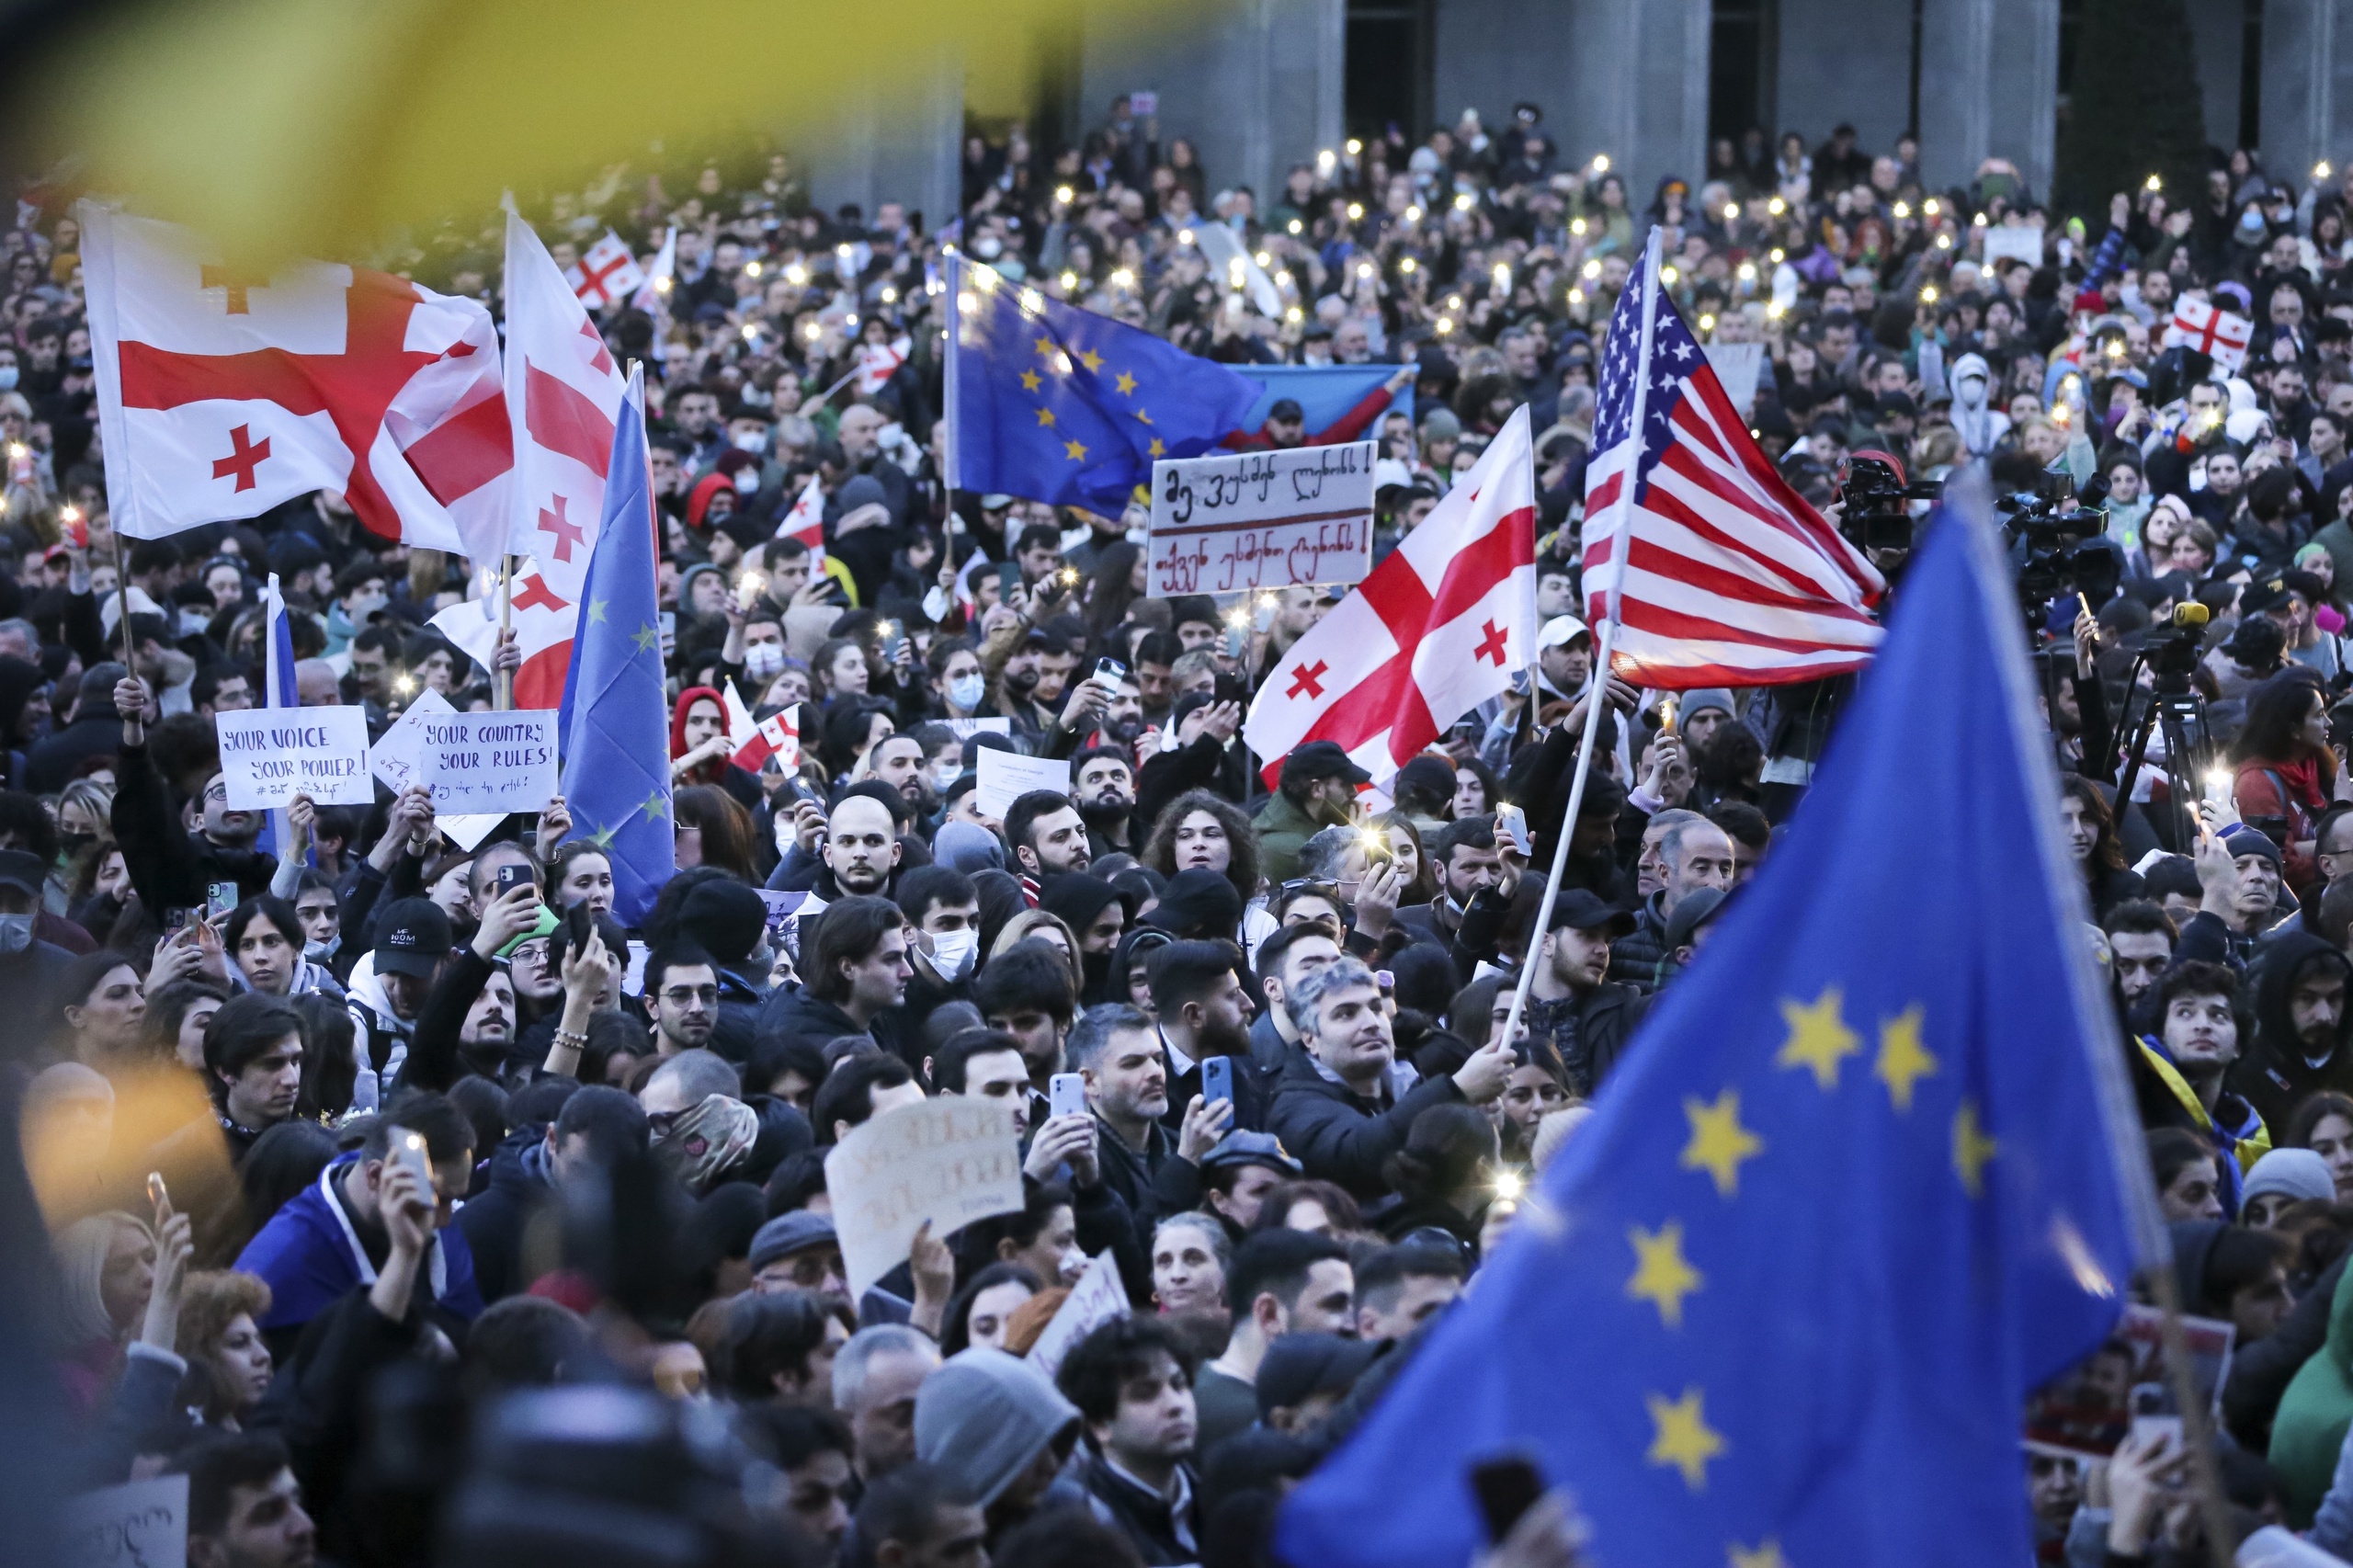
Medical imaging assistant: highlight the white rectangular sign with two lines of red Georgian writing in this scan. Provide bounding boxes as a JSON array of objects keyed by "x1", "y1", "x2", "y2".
[{"x1": 1143, "y1": 440, "x2": 1371, "y2": 598}]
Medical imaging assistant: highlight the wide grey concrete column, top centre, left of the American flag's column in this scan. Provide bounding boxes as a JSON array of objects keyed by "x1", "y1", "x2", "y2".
[{"x1": 1080, "y1": 0, "x2": 1348, "y2": 210}]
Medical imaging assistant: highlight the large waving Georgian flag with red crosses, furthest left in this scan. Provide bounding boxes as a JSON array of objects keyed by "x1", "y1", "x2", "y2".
[{"x1": 80, "y1": 202, "x2": 513, "y2": 551}]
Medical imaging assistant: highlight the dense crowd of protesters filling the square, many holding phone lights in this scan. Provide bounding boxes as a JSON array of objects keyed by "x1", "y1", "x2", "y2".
[{"x1": 14, "y1": 82, "x2": 2353, "y2": 1568}]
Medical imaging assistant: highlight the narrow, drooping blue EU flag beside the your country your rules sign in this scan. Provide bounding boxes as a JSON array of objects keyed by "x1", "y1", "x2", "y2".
[{"x1": 545, "y1": 369, "x2": 677, "y2": 926}]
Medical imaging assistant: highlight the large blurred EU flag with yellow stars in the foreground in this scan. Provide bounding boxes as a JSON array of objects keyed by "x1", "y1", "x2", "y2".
[{"x1": 1278, "y1": 506, "x2": 2163, "y2": 1568}]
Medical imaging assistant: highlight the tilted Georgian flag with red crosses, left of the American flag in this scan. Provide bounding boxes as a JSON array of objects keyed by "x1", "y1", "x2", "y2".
[{"x1": 1243, "y1": 405, "x2": 1537, "y2": 784}]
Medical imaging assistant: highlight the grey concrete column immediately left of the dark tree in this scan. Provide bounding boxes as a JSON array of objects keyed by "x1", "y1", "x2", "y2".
[{"x1": 1919, "y1": 0, "x2": 2052, "y2": 200}]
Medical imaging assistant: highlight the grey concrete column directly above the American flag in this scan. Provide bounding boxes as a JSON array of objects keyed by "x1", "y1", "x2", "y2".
[{"x1": 1541, "y1": 0, "x2": 1712, "y2": 195}]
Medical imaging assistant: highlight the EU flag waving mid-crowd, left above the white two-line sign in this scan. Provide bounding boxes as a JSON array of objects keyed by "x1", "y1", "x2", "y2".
[{"x1": 949, "y1": 255, "x2": 1259, "y2": 518}]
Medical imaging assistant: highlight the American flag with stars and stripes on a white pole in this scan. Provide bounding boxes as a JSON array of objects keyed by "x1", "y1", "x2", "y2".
[{"x1": 1584, "y1": 233, "x2": 1887, "y2": 690}]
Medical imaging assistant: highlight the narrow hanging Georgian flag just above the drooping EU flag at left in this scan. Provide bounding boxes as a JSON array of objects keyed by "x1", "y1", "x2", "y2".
[{"x1": 501, "y1": 212, "x2": 623, "y2": 603}]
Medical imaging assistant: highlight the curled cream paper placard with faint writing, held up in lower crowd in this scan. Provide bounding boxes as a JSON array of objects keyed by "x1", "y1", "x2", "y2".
[{"x1": 826, "y1": 1095, "x2": 1021, "y2": 1300}]
